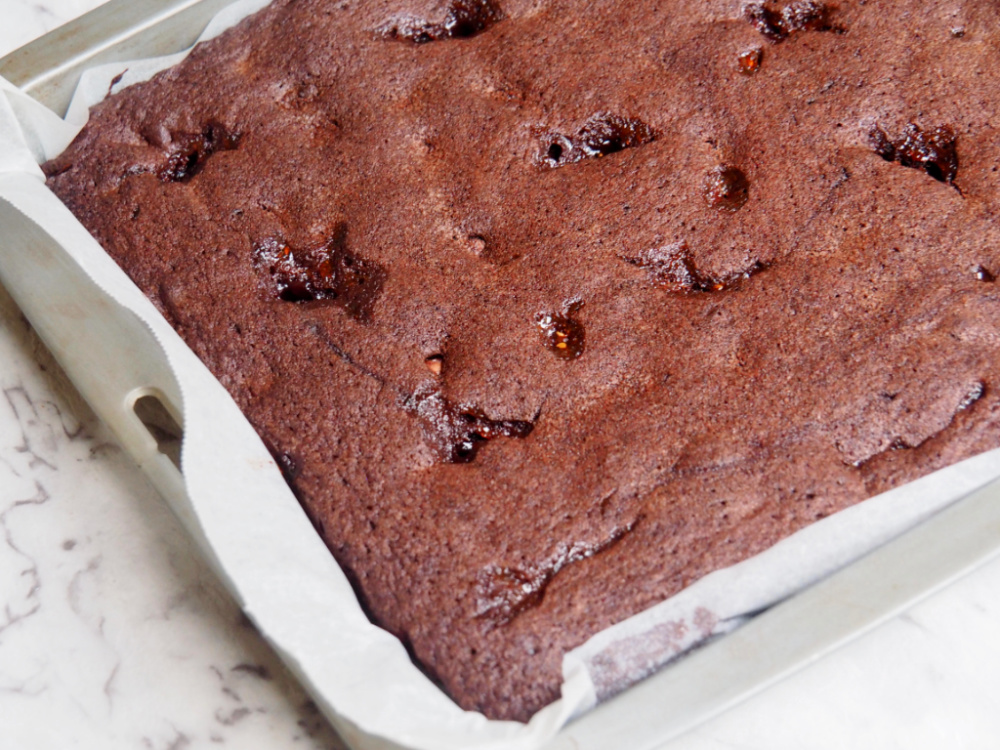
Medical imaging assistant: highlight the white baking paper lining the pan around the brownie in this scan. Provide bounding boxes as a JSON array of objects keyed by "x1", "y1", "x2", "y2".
[{"x1": 0, "y1": 0, "x2": 1000, "y2": 750}]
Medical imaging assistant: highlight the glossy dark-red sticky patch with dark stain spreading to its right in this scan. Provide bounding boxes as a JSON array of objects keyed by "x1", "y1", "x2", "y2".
[{"x1": 254, "y1": 220, "x2": 387, "y2": 322}]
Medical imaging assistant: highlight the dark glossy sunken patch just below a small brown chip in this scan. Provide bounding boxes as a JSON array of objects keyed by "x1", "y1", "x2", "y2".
[{"x1": 406, "y1": 386, "x2": 535, "y2": 464}]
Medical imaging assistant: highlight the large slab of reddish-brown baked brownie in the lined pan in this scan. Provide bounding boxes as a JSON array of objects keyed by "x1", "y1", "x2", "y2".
[{"x1": 46, "y1": 0, "x2": 1000, "y2": 719}]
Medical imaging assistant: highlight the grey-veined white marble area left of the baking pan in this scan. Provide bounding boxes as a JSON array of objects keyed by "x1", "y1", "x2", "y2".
[{"x1": 0, "y1": 290, "x2": 350, "y2": 750}]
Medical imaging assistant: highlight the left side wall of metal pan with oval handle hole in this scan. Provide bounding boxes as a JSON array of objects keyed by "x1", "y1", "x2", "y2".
[{"x1": 0, "y1": 183, "x2": 188, "y2": 512}]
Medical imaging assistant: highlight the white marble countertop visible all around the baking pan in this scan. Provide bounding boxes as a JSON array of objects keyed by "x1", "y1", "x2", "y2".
[{"x1": 0, "y1": 0, "x2": 1000, "y2": 750}]
